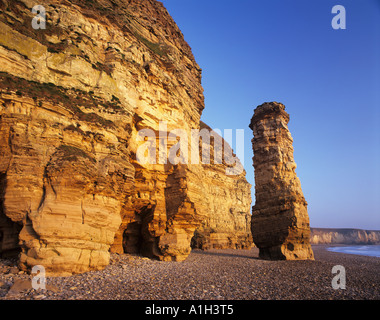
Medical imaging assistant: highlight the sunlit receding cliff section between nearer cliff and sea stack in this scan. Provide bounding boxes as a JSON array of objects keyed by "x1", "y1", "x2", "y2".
[{"x1": 192, "y1": 122, "x2": 253, "y2": 250}]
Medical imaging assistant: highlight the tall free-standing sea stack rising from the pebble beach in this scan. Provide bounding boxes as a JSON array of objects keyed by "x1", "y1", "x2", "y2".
[{"x1": 250, "y1": 102, "x2": 314, "y2": 260}]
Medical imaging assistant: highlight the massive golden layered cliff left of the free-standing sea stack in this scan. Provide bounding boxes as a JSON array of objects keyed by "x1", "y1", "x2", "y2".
[{"x1": 0, "y1": 0, "x2": 251, "y2": 275}]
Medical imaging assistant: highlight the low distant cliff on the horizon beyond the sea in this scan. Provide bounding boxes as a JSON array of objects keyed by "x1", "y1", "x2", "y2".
[{"x1": 310, "y1": 228, "x2": 380, "y2": 245}]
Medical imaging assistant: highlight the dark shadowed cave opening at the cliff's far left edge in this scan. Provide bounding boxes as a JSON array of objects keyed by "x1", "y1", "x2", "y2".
[{"x1": 0, "y1": 173, "x2": 22, "y2": 258}]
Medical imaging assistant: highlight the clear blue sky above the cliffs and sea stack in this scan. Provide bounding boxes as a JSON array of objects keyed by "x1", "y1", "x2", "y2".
[{"x1": 162, "y1": 0, "x2": 380, "y2": 230}]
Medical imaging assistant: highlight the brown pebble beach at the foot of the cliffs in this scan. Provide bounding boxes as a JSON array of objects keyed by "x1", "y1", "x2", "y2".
[{"x1": 0, "y1": 246, "x2": 380, "y2": 300}]
